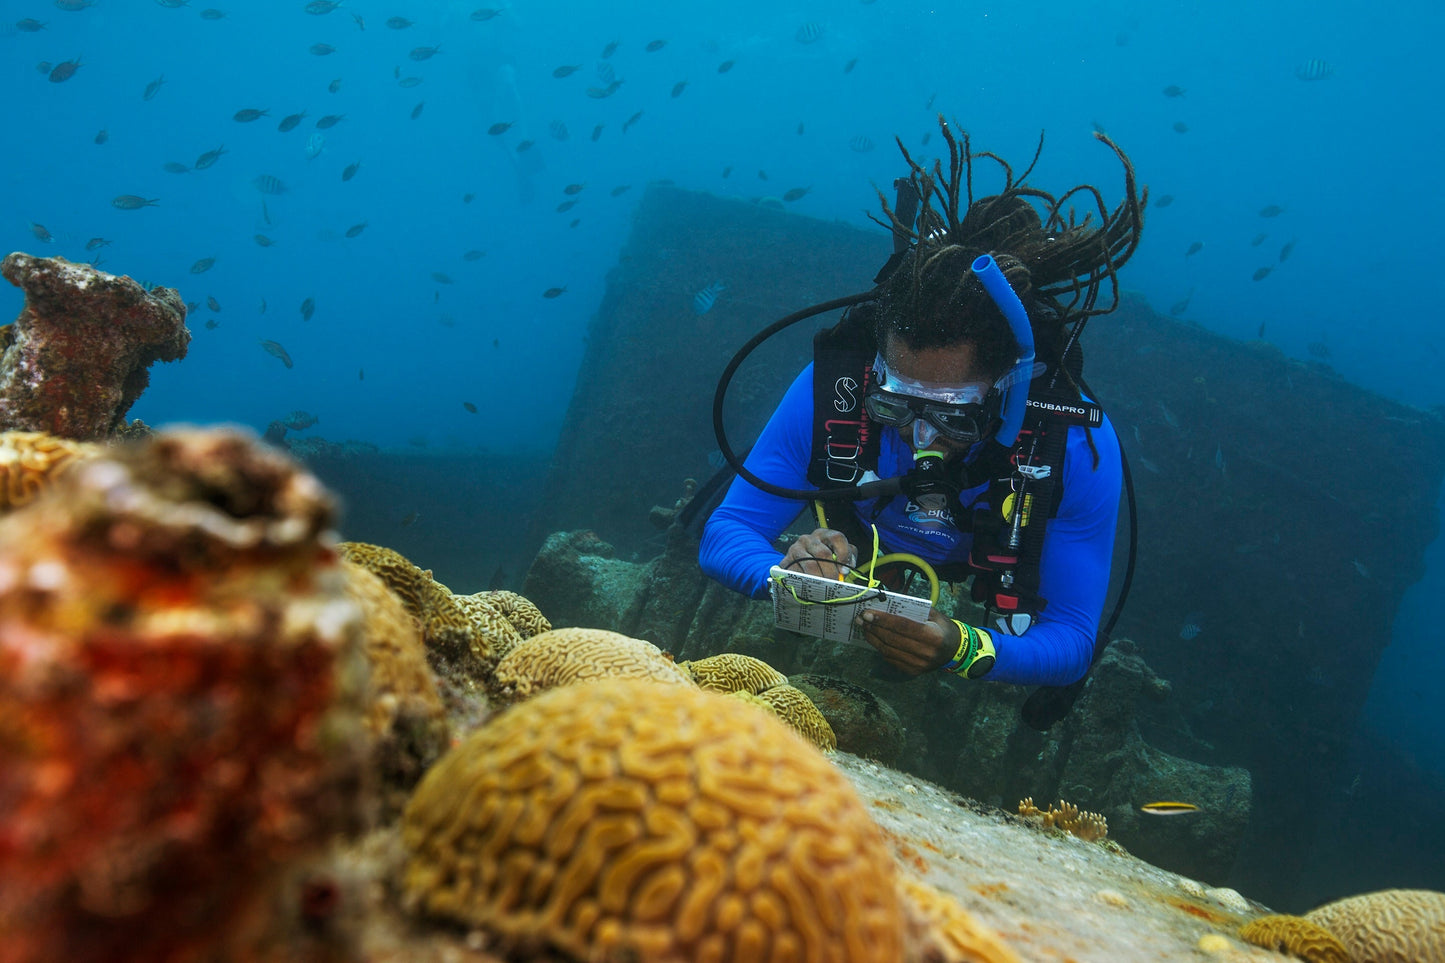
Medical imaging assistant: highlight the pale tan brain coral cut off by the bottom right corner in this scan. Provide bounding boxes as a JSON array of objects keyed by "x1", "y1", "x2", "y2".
[{"x1": 1305, "y1": 889, "x2": 1445, "y2": 963}]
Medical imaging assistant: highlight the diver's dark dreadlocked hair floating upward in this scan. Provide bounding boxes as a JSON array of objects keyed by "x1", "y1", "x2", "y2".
[{"x1": 870, "y1": 114, "x2": 1149, "y2": 383}]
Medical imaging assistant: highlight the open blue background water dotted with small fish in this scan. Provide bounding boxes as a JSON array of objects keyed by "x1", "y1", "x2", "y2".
[{"x1": 8, "y1": 0, "x2": 1445, "y2": 850}]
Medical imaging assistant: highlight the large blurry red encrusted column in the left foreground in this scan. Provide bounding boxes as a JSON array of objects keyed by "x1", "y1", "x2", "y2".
[{"x1": 0, "y1": 431, "x2": 368, "y2": 962}]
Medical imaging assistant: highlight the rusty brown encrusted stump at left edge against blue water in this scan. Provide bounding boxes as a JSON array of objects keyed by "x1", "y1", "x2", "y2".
[{"x1": 0, "y1": 253, "x2": 191, "y2": 441}]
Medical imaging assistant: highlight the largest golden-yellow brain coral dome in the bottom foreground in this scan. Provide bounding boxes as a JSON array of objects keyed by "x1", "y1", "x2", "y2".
[{"x1": 402, "y1": 678, "x2": 907, "y2": 962}]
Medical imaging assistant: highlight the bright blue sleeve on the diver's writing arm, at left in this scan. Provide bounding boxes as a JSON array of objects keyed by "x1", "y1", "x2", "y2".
[{"x1": 698, "y1": 364, "x2": 816, "y2": 599}]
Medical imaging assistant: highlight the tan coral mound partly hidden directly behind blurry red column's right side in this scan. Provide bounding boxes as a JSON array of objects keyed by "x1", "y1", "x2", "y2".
[{"x1": 341, "y1": 561, "x2": 451, "y2": 816}]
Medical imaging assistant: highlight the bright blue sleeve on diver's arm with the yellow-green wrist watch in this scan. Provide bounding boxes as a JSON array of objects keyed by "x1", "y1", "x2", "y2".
[{"x1": 987, "y1": 419, "x2": 1123, "y2": 685}]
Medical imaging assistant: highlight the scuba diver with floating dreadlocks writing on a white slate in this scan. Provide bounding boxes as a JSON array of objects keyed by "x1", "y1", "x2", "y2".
[{"x1": 699, "y1": 117, "x2": 1147, "y2": 691}]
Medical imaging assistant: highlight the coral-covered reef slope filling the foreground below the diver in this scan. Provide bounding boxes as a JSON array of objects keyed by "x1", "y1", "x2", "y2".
[{"x1": 0, "y1": 429, "x2": 1445, "y2": 963}]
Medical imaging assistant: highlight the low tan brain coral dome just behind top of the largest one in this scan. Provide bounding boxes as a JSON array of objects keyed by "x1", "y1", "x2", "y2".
[{"x1": 497, "y1": 629, "x2": 694, "y2": 700}]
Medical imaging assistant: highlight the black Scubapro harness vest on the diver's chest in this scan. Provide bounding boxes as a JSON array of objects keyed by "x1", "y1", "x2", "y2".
[{"x1": 808, "y1": 309, "x2": 1104, "y2": 635}]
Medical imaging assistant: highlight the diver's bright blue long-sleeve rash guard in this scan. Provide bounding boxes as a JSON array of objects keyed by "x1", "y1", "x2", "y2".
[{"x1": 698, "y1": 364, "x2": 1123, "y2": 685}]
